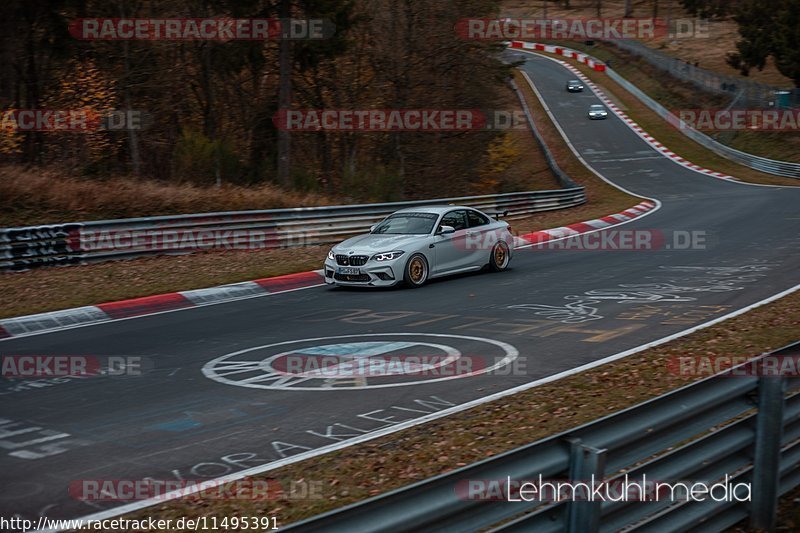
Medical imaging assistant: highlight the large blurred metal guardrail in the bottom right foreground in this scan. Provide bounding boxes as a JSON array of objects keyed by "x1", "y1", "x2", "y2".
[{"x1": 286, "y1": 343, "x2": 800, "y2": 533}]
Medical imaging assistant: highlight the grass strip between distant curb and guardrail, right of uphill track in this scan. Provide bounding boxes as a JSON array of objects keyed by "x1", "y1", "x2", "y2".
[{"x1": 524, "y1": 47, "x2": 800, "y2": 187}]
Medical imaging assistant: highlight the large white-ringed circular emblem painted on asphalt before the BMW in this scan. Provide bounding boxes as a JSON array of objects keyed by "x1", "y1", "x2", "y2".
[{"x1": 202, "y1": 333, "x2": 519, "y2": 391}]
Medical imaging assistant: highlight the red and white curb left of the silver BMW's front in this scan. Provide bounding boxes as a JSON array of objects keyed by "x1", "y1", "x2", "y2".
[{"x1": 0, "y1": 270, "x2": 324, "y2": 339}]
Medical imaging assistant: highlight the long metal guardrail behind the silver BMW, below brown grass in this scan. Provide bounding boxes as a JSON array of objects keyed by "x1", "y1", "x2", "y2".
[{"x1": 0, "y1": 187, "x2": 586, "y2": 271}]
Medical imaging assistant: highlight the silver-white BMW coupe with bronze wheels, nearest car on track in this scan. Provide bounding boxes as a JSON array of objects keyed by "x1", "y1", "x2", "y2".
[{"x1": 325, "y1": 205, "x2": 514, "y2": 287}]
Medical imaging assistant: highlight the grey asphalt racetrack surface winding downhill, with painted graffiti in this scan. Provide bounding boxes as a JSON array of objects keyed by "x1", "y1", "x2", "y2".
[{"x1": 0, "y1": 55, "x2": 800, "y2": 518}]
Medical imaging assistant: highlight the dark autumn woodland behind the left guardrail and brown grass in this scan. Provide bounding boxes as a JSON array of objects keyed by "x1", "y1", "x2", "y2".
[{"x1": 0, "y1": 0, "x2": 520, "y2": 200}]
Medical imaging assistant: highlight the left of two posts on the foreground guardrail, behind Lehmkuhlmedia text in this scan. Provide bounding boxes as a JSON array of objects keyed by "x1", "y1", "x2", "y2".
[{"x1": 567, "y1": 439, "x2": 606, "y2": 533}]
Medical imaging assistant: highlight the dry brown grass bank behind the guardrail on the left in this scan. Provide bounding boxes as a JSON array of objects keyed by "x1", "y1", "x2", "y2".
[{"x1": 0, "y1": 166, "x2": 332, "y2": 226}]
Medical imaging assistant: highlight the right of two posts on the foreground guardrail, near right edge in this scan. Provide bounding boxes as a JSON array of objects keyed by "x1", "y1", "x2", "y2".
[{"x1": 750, "y1": 376, "x2": 786, "y2": 531}]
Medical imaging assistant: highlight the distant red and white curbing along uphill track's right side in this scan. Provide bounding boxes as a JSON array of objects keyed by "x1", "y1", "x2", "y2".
[{"x1": 510, "y1": 41, "x2": 739, "y2": 182}]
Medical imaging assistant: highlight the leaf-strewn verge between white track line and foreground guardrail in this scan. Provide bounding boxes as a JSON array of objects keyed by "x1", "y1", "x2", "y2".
[{"x1": 103, "y1": 291, "x2": 800, "y2": 525}]
